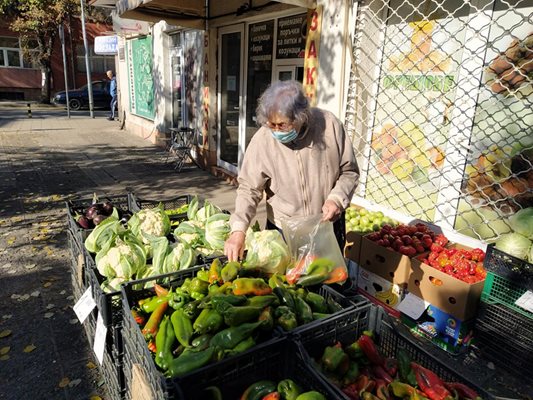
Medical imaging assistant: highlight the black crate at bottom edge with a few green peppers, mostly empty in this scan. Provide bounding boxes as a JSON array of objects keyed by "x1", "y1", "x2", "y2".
[{"x1": 177, "y1": 338, "x2": 337, "y2": 400}]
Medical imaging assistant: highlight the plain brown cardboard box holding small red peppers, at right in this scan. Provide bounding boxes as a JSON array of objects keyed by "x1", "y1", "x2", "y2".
[{"x1": 407, "y1": 258, "x2": 485, "y2": 321}]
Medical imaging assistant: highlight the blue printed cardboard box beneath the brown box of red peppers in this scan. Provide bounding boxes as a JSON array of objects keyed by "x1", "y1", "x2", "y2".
[{"x1": 398, "y1": 293, "x2": 474, "y2": 354}]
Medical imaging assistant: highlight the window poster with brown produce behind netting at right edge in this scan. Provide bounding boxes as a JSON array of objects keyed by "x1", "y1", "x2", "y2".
[{"x1": 455, "y1": 3, "x2": 533, "y2": 242}]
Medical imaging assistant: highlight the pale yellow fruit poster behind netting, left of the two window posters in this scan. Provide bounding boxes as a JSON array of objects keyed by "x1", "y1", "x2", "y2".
[{"x1": 366, "y1": 1, "x2": 466, "y2": 220}]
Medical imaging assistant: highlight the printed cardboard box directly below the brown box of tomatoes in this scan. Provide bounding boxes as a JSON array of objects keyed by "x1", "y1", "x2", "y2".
[{"x1": 357, "y1": 267, "x2": 405, "y2": 309}]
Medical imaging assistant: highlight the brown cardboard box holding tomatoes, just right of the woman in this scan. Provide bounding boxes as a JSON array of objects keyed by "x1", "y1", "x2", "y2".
[{"x1": 359, "y1": 236, "x2": 411, "y2": 287}]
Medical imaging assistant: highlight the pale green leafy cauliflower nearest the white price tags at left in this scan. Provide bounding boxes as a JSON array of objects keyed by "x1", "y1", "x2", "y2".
[{"x1": 96, "y1": 232, "x2": 146, "y2": 280}]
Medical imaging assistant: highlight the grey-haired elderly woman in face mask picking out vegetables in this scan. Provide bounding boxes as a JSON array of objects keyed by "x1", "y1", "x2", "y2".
[{"x1": 224, "y1": 81, "x2": 359, "y2": 261}]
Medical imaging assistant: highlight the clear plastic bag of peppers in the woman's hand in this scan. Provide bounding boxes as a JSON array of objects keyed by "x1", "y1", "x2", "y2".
[{"x1": 281, "y1": 214, "x2": 348, "y2": 286}]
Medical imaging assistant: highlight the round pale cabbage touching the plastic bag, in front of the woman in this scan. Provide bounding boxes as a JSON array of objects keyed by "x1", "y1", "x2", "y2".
[{"x1": 244, "y1": 229, "x2": 291, "y2": 274}]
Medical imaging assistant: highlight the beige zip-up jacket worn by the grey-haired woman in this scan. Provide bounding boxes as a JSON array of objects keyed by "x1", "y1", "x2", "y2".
[{"x1": 230, "y1": 108, "x2": 359, "y2": 231}]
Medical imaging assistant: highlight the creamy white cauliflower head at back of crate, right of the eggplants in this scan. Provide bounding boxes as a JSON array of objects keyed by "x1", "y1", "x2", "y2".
[{"x1": 128, "y1": 203, "x2": 170, "y2": 243}]
